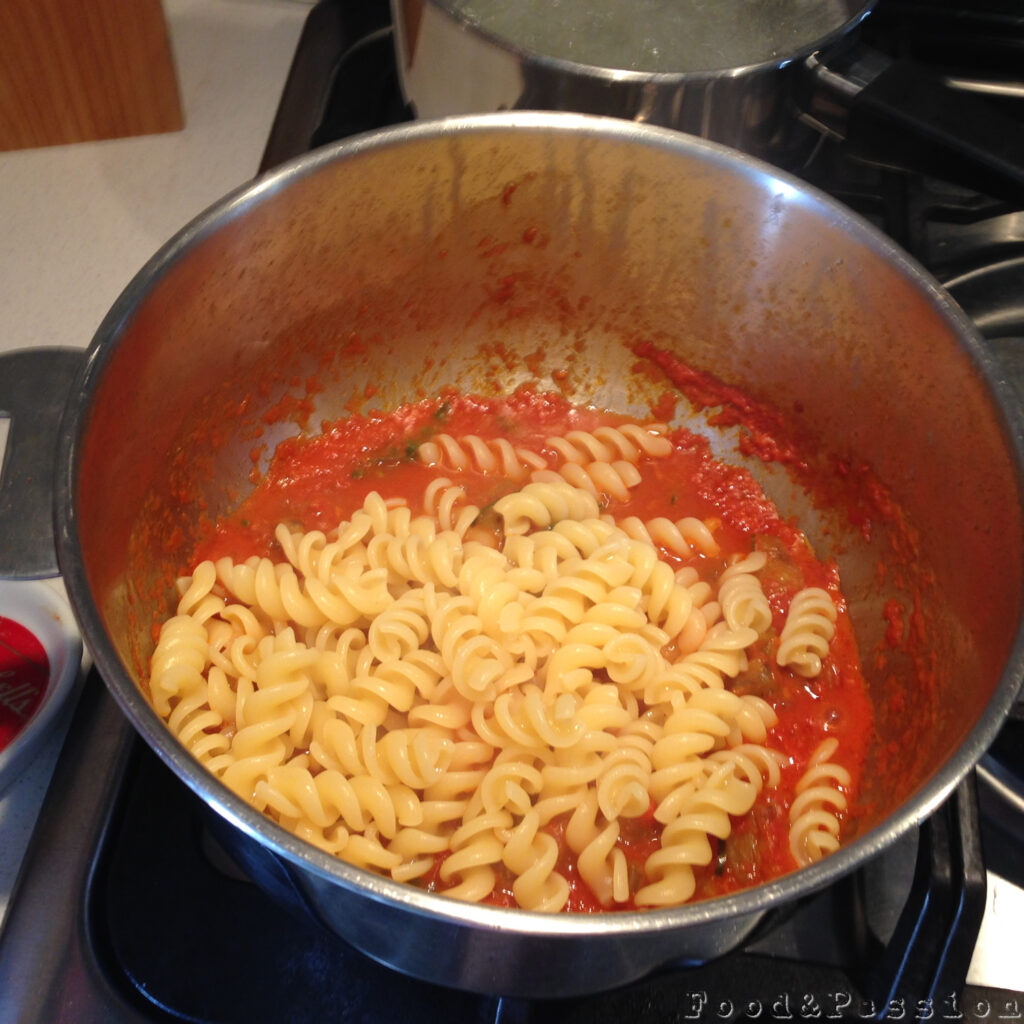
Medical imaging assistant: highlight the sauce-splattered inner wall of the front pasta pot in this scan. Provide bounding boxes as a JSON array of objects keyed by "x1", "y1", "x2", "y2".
[{"x1": 76, "y1": 119, "x2": 1022, "y2": 856}]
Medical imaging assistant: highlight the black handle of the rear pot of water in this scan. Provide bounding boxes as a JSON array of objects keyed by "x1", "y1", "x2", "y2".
[{"x1": 802, "y1": 48, "x2": 1024, "y2": 204}]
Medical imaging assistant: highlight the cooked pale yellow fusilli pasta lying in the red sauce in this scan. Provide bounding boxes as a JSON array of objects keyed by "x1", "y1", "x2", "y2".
[{"x1": 150, "y1": 415, "x2": 850, "y2": 911}]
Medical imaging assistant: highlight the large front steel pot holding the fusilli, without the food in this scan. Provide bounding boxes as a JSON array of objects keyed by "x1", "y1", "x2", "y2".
[{"x1": 56, "y1": 114, "x2": 1024, "y2": 996}]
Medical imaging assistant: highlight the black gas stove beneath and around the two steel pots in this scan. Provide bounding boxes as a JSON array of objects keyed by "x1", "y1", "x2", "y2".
[{"x1": 0, "y1": 0, "x2": 1024, "y2": 1024}]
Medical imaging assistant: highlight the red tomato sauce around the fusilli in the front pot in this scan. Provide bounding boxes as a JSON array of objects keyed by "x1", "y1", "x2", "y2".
[{"x1": 188, "y1": 380, "x2": 876, "y2": 911}]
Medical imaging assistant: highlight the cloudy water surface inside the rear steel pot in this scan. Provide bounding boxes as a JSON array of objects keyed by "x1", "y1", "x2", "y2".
[{"x1": 440, "y1": 0, "x2": 873, "y2": 74}]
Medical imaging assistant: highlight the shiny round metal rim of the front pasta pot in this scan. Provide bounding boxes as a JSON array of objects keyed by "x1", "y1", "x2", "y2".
[{"x1": 54, "y1": 112, "x2": 1024, "y2": 938}]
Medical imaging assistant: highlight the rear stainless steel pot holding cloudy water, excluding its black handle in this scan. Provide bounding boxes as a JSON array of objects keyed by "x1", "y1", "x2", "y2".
[{"x1": 391, "y1": 0, "x2": 874, "y2": 166}]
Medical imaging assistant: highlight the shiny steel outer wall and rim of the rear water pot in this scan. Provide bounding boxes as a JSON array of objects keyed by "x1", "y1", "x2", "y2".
[{"x1": 391, "y1": 0, "x2": 874, "y2": 167}]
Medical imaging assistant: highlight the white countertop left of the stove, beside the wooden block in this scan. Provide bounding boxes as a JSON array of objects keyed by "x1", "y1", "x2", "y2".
[{"x1": 0, "y1": 0, "x2": 309, "y2": 925}]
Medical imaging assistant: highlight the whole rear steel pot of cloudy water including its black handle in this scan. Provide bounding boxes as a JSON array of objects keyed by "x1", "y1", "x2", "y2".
[{"x1": 390, "y1": 0, "x2": 1024, "y2": 200}]
